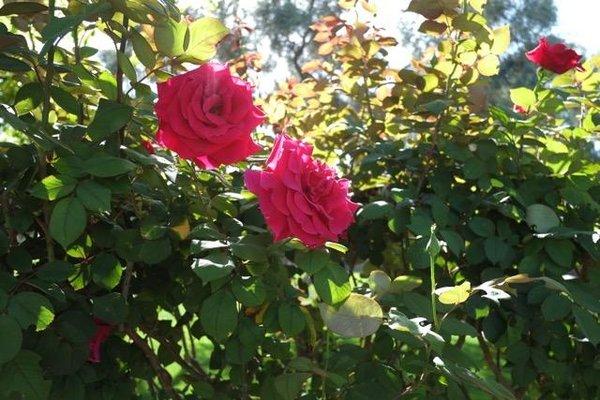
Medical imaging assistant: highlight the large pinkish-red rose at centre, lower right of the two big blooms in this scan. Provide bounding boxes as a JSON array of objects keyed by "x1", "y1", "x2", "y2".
[{"x1": 244, "y1": 135, "x2": 358, "y2": 248}]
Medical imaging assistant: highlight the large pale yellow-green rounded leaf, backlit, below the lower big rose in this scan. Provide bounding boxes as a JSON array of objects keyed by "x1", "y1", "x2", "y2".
[{"x1": 319, "y1": 293, "x2": 383, "y2": 338}]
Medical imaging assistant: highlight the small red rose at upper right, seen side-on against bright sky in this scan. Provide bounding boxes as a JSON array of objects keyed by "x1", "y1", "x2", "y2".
[{"x1": 525, "y1": 38, "x2": 584, "y2": 74}]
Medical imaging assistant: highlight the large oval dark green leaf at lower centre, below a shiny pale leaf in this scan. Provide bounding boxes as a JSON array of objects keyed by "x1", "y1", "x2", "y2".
[{"x1": 200, "y1": 290, "x2": 238, "y2": 342}]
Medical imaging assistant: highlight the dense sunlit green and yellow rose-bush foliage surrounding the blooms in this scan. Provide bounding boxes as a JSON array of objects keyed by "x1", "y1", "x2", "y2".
[{"x1": 0, "y1": 0, "x2": 600, "y2": 400}]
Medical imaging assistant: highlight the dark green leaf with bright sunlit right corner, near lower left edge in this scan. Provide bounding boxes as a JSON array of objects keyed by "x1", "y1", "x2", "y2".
[{"x1": 8, "y1": 292, "x2": 54, "y2": 331}]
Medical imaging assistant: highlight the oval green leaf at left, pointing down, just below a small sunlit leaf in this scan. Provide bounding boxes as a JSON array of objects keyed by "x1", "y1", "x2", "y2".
[{"x1": 50, "y1": 197, "x2": 87, "y2": 249}]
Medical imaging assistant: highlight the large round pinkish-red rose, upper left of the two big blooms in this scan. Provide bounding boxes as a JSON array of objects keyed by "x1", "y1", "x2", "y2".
[{"x1": 155, "y1": 63, "x2": 264, "y2": 169}]
